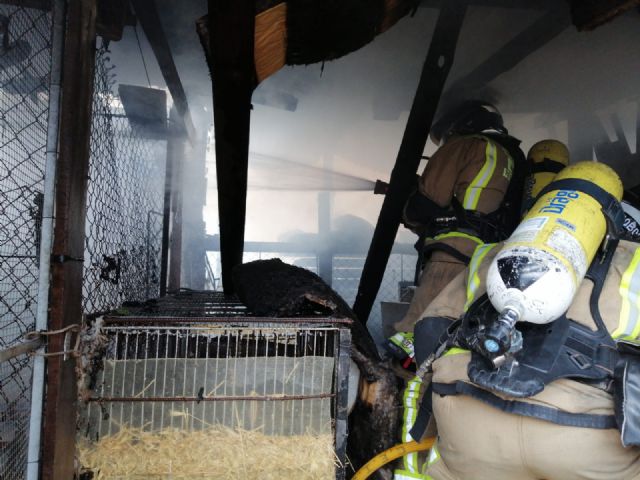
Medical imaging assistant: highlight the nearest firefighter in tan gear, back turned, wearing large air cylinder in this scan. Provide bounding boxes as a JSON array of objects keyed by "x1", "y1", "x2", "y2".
[{"x1": 411, "y1": 162, "x2": 640, "y2": 480}]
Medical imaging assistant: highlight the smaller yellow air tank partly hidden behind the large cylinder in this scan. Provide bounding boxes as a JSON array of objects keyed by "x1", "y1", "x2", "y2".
[{"x1": 522, "y1": 140, "x2": 569, "y2": 212}]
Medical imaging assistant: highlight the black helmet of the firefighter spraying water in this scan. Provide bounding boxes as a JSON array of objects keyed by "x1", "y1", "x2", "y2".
[{"x1": 430, "y1": 100, "x2": 509, "y2": 144}]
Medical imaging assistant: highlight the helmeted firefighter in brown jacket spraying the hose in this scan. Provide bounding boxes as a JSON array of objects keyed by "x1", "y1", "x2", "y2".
[{"x1": 394, "y1": 100, "x2": 524, "y2": 341}]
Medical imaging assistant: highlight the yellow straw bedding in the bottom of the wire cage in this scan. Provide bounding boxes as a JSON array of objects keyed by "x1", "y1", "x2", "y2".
[{"x1": 78, "y1": 427, "x2": 335, "y2": 480}]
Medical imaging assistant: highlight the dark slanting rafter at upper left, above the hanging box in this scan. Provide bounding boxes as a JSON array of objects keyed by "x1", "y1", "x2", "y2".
[{"x1": 131, "y1": 0, "x2": 195, "y2": 139}]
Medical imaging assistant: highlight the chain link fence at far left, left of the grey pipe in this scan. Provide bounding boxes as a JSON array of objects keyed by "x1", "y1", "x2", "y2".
[{"x1": 0, "y1": 5, "x2": 53, "y2": 480}]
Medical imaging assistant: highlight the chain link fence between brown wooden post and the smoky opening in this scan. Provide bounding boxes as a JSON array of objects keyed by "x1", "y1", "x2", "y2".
[{"x1": 83, "y1": 42, "x2": 166, "y2": 313}]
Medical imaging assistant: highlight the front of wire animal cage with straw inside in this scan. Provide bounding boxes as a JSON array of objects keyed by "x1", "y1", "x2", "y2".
[{"x1": 79, "y1": 318, "x2": 349, "y2": 479}]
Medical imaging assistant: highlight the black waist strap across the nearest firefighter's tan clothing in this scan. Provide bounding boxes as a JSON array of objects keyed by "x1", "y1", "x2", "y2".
[{"x1": 432, "y1": 381, "x2": 616, "y2": 430}]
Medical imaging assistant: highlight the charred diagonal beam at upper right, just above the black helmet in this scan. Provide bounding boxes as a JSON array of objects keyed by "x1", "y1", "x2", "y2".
[{"x1": 443, "y1": 2, "x2": 571, "y2": 104}]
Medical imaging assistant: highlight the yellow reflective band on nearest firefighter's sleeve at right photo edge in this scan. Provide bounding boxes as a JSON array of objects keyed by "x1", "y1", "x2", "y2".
[{"x1": 611, "y1": 248, "x2": 640, "y2": 342}]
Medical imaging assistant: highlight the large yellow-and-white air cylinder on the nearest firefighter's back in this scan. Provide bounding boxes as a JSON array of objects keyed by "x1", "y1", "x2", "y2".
[{"x1": 487, "y1": 161, "x2": 623, "y2": 323}]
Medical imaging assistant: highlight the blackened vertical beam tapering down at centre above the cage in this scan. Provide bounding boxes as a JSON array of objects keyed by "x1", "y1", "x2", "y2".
[{"x1": 208, "y1": 0, "x2": 256, "y2": 293}]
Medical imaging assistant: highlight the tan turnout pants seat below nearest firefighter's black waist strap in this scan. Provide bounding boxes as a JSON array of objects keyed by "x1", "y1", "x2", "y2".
[{"x1": 427, "y1": 395, "x2": 640, "y2": 480}]
